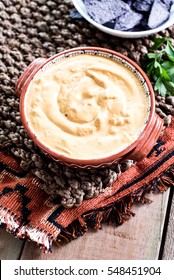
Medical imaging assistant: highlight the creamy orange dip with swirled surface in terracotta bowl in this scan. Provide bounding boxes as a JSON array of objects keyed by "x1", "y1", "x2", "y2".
[{"x1": 25, "y1": 54, "x2": 148, "y2": 159}]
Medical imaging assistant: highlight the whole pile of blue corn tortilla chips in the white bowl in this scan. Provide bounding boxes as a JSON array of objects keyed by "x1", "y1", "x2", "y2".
[{"x1": 83, "y1": 0, "x2": 174, "y2": 31}]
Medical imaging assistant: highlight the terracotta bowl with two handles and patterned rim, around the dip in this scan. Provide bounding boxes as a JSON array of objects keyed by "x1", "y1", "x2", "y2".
[{"x1": 16, "y1": 47, "x2": 163, "y2": 169}]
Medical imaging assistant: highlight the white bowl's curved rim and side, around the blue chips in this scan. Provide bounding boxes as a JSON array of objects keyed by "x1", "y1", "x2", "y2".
[{"x1": 72, "y1": 0, "x2": 174, "y2": 38}]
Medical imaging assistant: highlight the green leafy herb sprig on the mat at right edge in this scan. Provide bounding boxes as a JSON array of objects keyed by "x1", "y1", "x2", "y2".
[{"x1": 143, "y1": 38, "x2": 174, "y2": 96}]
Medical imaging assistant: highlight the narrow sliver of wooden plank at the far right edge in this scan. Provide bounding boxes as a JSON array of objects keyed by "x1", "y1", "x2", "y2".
[{"x1": 162, "y1": 190, "x2": 174, "y2": 260}]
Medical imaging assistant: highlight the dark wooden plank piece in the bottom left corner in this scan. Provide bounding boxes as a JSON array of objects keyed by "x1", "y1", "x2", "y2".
[{"x1": 0, "y1": 228, "x2": 25, "y2": 260}]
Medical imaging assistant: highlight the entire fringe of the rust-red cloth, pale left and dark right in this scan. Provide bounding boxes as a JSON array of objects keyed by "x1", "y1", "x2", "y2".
[{"x1": 0, "y1": 165, "x2": 174, "y2": 253}]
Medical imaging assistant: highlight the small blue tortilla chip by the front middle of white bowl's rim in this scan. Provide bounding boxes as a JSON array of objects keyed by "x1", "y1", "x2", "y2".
[{"x1": 114, "y1": 9, "x2": 143, "y2": 31}]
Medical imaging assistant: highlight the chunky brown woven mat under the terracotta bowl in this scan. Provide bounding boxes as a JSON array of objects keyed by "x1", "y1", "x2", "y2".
[{"x1": 0, "y1": 0, "x2": 174, "y2": 208}]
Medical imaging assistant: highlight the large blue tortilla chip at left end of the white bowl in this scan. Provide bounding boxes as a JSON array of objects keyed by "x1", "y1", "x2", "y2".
[{"x1": 84, "y1": 0, "x2": 130, "y2": 24}]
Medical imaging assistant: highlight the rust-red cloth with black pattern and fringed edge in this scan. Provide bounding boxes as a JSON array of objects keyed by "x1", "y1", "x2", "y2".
[{"x1": 0, "y1": 118, "x2": 174, "y2": 252}]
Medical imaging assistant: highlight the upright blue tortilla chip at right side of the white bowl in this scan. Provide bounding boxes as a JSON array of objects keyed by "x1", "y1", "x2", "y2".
[{"x1": 147, "y1": 0, "x2": 170, "y2": 29}]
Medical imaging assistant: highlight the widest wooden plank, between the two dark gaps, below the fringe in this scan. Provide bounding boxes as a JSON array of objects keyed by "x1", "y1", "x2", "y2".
[{"x1": 21, "y1": 191, "x2": 169, "y2": 260}]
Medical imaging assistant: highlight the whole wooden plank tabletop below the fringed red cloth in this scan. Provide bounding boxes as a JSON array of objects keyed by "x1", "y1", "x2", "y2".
[{"x1": 0, "y1": 189, "x2": 174, "y2": 260}]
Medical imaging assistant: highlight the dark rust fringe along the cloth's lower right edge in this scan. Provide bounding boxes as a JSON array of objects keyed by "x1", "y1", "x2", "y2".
[{"x1": 56, "y1": 165, "x2": 174, "y2": 244}]
